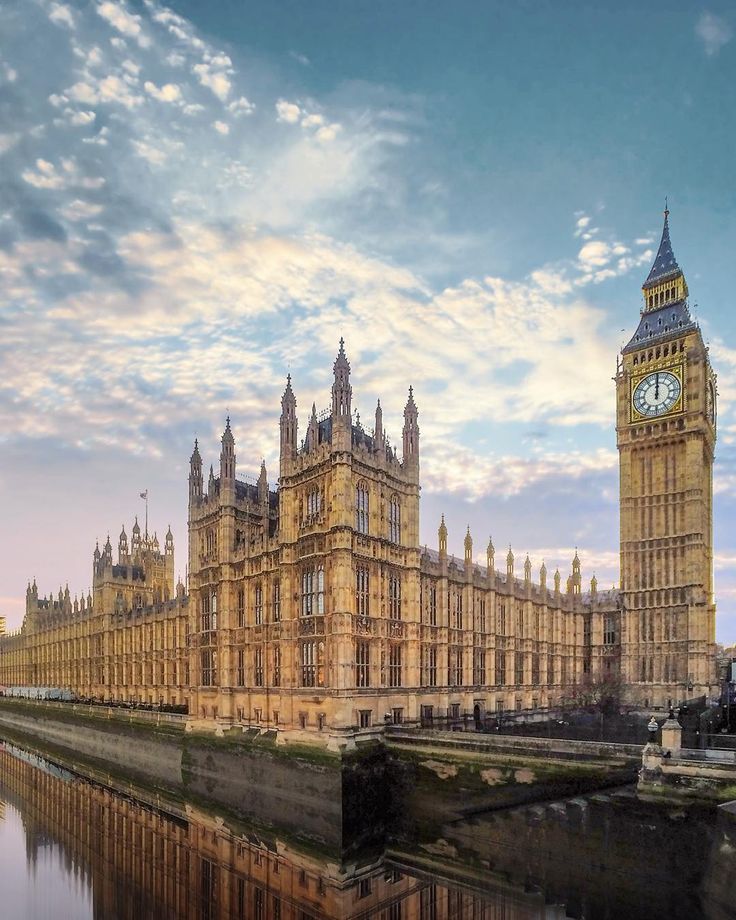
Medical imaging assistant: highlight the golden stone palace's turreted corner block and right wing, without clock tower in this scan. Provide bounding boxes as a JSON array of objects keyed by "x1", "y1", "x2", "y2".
[{"x1": 184, "y1": 344, "x2": 620, "y2": 735}]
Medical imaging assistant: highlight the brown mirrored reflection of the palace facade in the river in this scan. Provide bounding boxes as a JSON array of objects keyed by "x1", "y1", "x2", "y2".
[{"x1": 0, "y1": 743, "x2": 544, "y2": 920}]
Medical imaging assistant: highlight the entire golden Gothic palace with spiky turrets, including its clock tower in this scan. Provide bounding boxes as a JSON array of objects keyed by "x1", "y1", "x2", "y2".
[{"x1": 0, "y1": 211, "x2": 716, "y2": 740}]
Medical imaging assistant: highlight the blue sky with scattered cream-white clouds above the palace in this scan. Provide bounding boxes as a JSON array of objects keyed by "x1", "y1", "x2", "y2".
[{"x1": 0, "y1": 0, "x2": 736, "y2": 643}]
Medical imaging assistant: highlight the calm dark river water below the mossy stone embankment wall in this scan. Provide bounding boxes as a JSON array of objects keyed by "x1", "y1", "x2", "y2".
[{"x1": 0, "y1": 742, "x2": 736, "y2": 920}]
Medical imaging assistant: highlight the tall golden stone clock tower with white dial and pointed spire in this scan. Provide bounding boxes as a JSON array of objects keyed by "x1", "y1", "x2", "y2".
[{"x1": 616, "y1": 210, "x2": 716, "y2": 705}]
